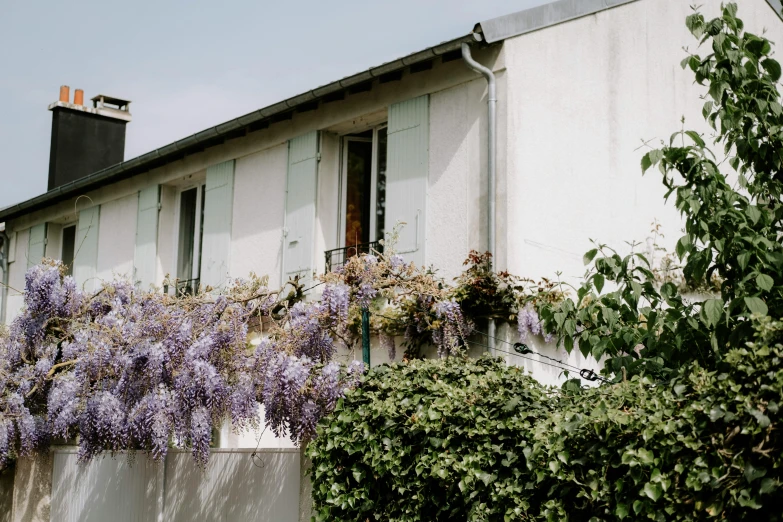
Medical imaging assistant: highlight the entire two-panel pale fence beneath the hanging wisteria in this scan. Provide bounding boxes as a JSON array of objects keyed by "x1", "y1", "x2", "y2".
[{"x1": 51, "y1": 448, "x2": 300, "y2": 522}]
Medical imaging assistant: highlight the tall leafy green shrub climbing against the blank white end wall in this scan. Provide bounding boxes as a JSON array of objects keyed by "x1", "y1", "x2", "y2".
[{"x1": 538, "y1": 4, "x2": 783, "y2": 378}]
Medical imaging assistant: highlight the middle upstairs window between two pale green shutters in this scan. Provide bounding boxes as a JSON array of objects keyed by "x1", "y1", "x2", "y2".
[{"x1": 177, "y1": 185, "x2": 205, "y2": 294}]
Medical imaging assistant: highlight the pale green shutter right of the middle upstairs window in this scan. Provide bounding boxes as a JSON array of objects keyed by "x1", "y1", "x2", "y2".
[{"x1": 201, "y1": 160, "x2": 234, "y2": 288}]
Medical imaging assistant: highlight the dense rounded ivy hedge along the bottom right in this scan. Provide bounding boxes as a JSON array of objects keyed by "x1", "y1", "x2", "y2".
[{"x1": 308, "y1": 318, "x2": 783, "y2": 522}]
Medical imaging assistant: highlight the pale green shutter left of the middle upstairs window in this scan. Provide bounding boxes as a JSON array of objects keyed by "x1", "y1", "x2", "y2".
[{"x1": 133, "y1": 185, "x2": 160, "y2": 290}]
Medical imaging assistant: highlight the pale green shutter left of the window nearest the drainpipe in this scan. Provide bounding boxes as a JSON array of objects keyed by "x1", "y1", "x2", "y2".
[{"x1": 283, "y1": 131, "x2": 318, "y2": 281}]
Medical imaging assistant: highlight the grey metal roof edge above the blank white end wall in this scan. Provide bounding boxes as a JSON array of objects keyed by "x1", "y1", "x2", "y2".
[{"x1": 479, "y1": 0, "x2": 640, "y2": 43}]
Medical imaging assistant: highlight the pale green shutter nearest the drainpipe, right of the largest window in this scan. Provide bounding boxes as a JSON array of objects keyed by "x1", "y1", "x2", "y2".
[{"x1": 385, "y1": 95, "x2": 430, "y2": 266}]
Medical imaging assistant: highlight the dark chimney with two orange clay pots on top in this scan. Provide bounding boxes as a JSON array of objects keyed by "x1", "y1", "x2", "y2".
[{"x1": 48, "y1": 85, "x2": 131, "y2": 190}]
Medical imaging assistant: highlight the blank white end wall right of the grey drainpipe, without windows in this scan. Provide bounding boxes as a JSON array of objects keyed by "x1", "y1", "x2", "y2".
[{"x1": 501, "y1": 0, "x2": 783, "y2": 283}]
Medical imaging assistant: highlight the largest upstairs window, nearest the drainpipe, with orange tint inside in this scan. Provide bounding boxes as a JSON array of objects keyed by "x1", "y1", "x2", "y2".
[{"x1": 340, "y1": 125, "x2": 386, "y2": 247}]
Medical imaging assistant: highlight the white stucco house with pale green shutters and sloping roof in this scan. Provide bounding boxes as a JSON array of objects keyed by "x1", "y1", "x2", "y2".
[{"x1": 0, "y1": 0, "x2": 783, "y2": 519}]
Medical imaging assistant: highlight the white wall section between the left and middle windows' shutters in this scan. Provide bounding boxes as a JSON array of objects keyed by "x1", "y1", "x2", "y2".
[{"x1": 95, "y1": 194, "x2": 139, "y2": 281}]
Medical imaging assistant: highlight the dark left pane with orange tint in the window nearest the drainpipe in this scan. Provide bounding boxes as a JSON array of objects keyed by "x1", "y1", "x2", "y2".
[{"x1": 345, "y1": 141, "x2": 372, "y2": 246}]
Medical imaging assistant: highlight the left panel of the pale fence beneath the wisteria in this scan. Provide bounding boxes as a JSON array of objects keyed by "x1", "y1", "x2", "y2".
[{"x1": 51, "y1": 451, "x2": 159, "y2": 522}]
